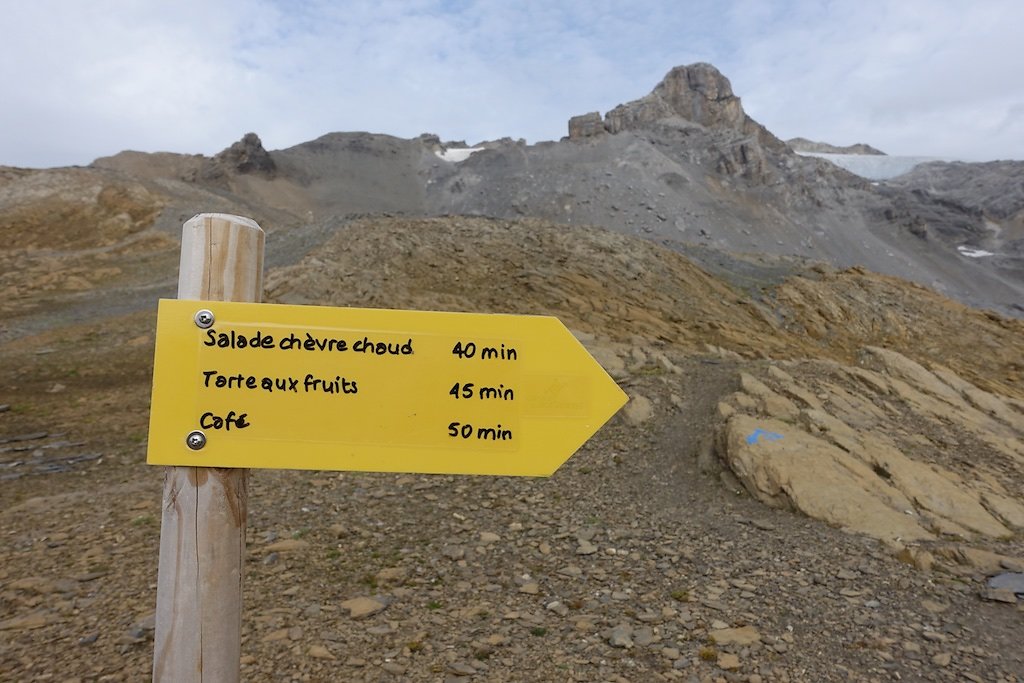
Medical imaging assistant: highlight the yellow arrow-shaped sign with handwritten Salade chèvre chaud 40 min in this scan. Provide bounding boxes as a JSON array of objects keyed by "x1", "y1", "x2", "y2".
[{"x1": 147, "y1": 300, "x2": 627, "y2": 476}]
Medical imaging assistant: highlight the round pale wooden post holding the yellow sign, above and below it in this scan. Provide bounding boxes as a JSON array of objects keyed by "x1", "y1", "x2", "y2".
[{"x1": 153, "y1": 213, "x2": 263, "y2": 683}]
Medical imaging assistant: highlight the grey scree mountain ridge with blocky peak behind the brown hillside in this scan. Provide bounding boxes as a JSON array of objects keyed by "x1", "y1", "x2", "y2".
[{"x1": 70, "y1": 63, "x2": 1024, "y2": 315}]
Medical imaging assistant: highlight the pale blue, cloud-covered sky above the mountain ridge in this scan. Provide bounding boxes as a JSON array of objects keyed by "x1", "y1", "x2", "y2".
[{"x1": 0, "y1": 0, "x2": 1024, "y2": 167}]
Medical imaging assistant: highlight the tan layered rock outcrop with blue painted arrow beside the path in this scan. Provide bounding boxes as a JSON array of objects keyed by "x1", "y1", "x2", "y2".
[{"x1": 718, "y1": 347, "x2": 1024, "y2": 566}]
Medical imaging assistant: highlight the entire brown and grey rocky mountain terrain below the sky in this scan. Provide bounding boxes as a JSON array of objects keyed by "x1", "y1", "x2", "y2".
[{"x1": 0, "y1": 61, "x2": 1024, "y2": 683}]
